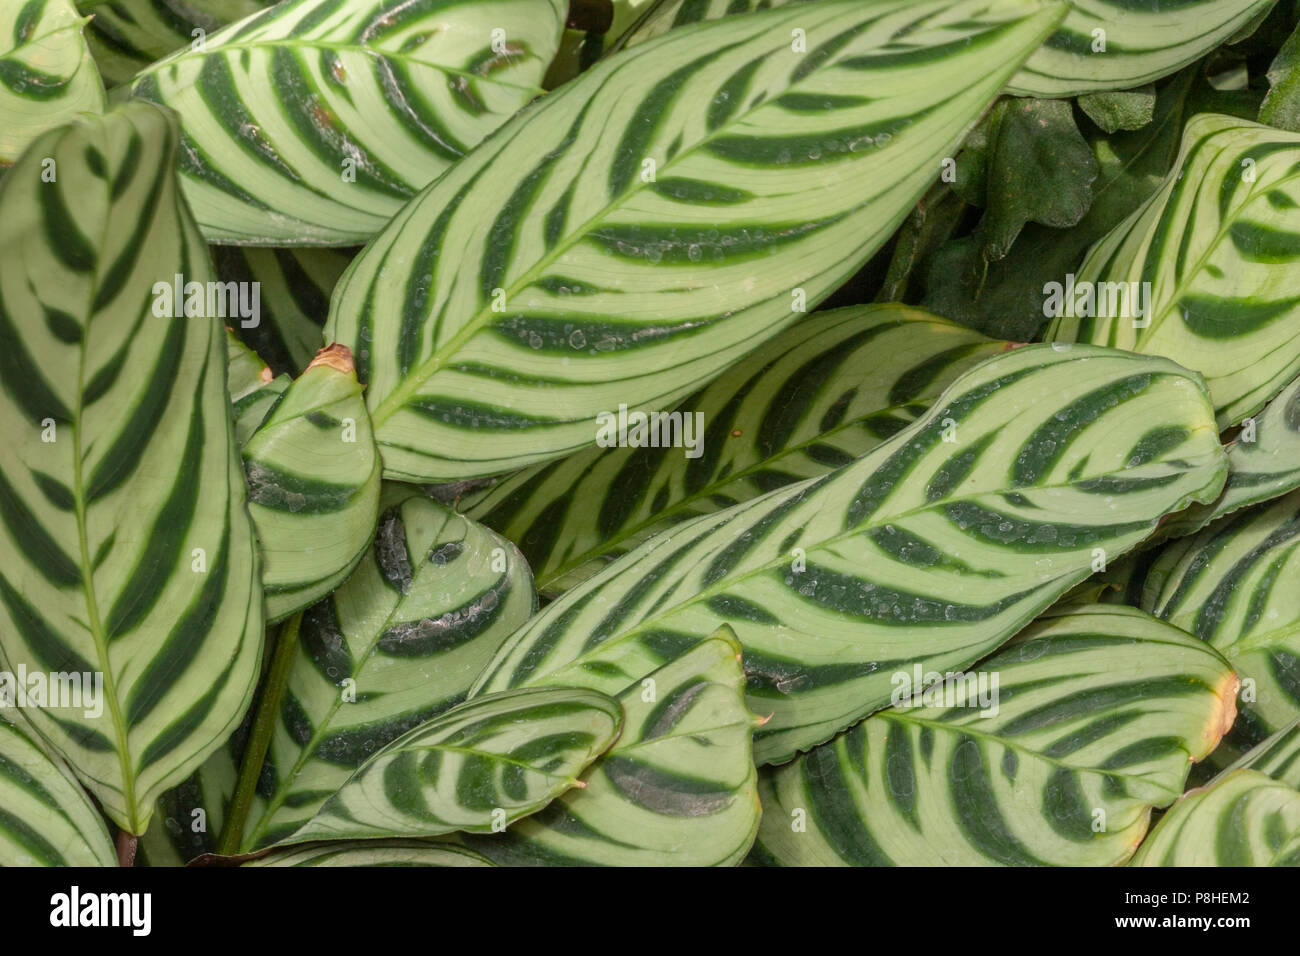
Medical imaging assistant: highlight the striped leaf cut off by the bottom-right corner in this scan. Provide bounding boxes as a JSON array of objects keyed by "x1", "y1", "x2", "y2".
[{"x1": 1130, "y1": 770, "x2": 1300, "y2": 866}]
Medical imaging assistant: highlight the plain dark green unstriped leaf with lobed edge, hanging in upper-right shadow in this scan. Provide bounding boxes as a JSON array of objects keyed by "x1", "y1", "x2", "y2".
[{"x1": 976, "y1": 99, "x2": 1099, "y2": 259}]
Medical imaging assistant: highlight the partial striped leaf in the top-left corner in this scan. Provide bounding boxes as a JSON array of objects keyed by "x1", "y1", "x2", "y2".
[{"x1": 0, "y1": 0, "x2": 104, "y2": 168}]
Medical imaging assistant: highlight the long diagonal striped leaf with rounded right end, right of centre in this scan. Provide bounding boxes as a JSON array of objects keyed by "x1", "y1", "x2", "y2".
[{"x1": 476, "y1": 346, "x2": 1226, "y2": 763}]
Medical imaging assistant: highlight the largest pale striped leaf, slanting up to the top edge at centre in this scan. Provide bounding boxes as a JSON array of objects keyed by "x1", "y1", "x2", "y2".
[{"x1": 326, "y1": 0, "x2": 1062, "y2": 481}]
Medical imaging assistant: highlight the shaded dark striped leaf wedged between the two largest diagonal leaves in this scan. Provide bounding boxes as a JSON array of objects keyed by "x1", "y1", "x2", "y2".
[{"x1": 465, "y1": 306, "x2": 1008, "y2": 596}]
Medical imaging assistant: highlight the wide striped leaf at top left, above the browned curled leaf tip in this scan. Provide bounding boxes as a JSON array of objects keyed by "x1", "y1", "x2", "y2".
[{"x1": 131, "y1": 0, "x2": 564, "y2": 246}]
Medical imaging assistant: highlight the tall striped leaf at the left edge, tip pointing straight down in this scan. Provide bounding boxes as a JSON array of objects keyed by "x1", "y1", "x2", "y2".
[{"x1": 0, "y1": 103, "x2": 263, "y2": 834}]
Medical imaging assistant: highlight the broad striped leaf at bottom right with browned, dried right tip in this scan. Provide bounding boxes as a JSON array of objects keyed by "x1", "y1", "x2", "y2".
[{"x1": 754, "y1": 605, "x2": 1238, "y2": 866}]
